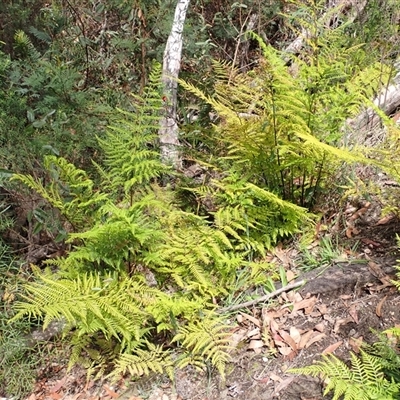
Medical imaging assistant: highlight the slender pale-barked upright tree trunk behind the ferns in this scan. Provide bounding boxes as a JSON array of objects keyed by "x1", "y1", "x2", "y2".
[{"x1": 159, "y1": 0, "x2": 190, "y2": 168}]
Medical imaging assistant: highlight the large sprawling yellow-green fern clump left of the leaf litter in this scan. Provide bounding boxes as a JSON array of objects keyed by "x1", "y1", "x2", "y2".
[{"x1": 8, "y1": 68, "x2": 310, "y2": 376}]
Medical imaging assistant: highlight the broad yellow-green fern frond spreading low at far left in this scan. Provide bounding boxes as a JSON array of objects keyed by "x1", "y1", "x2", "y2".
[{"x1": 13, "y1": 273, "x2": 153, "y2": 346}]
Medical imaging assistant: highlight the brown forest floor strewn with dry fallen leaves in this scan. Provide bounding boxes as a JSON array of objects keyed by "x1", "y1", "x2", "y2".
[{"x1": 17, "y1": 195, "x2": 400, "y2": 400}]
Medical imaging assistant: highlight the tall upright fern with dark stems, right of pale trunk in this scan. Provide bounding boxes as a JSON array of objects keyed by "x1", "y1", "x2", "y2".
[{"x1": 181, "y1": 22, "x2": 388, "y2": 207}]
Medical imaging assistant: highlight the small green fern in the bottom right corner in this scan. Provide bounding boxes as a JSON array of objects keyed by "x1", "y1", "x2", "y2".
[{"x1": 290, "y1": 351, "x2": 400, "y2": 400}]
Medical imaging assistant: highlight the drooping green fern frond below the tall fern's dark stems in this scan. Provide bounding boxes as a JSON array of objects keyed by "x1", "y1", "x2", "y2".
[{"x1": 192, "y1": 174, "x2": 312, "y2": 252}]
